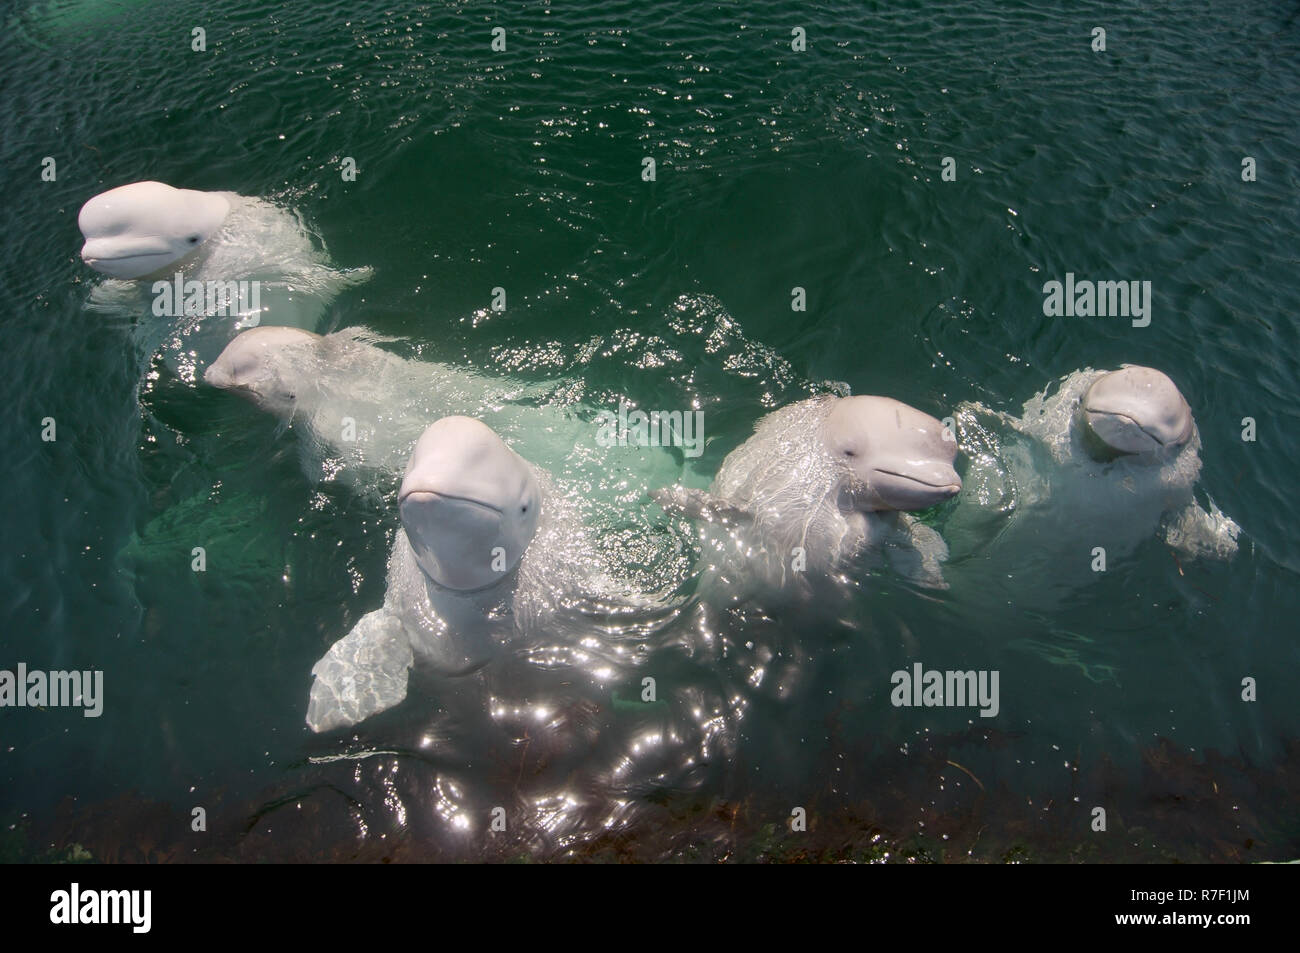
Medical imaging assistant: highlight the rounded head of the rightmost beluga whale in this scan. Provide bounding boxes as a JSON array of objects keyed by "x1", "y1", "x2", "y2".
[{"x1": 1079, "y1": 365, "x2": 1193, "y2": 460}]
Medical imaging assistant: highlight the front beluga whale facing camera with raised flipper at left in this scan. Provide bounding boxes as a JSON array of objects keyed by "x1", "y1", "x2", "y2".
[{"x1": 307, "y1": 416, "x2": 644, "y2": 732}]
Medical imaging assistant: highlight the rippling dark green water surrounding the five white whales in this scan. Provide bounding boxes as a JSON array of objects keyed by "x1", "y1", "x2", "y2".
[{"x1": 0, "y1": 0, "x2": 1300, "y2": 858}]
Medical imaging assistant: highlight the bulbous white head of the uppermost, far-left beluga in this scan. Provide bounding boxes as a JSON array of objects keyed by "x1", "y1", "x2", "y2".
[{"x1": 77, "y1": 182, "x2": 230, "y2": 280}]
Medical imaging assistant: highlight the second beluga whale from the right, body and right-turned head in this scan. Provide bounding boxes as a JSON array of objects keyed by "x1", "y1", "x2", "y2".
[{"x1": 654, "y1": 397, "x2": 961, "y2": 602}]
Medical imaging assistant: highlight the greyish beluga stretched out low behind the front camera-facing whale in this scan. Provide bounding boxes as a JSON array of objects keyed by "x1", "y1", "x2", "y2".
[{"x1": 204, "y1": 328, "x2": 684, "y2": 499}]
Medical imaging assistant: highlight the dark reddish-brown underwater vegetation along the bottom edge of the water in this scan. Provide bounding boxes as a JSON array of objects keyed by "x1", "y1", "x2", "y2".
[{"x1": 15, "y1": 725, "x2": 1300, "y2": 863}]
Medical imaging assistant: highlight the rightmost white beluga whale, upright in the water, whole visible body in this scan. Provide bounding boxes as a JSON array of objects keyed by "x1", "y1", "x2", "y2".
[{"x1": 944, "y1": 365, "x2": 1240, "y2": 605}]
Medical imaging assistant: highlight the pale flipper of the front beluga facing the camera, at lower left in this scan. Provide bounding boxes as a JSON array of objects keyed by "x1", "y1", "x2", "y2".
[{"x1": 307, "y1": 608, "x2": 415, "y2": 732}]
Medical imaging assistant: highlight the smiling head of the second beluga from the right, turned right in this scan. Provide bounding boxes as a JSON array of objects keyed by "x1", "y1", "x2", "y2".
[{"x1": 822, "y1": 397, "x2": 962, "y2": 510}]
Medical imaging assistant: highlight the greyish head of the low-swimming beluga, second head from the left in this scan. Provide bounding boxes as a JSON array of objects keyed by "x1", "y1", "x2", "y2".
[{"x1": 203, "y1": 325, "x2": 321, "y2": 419}]
